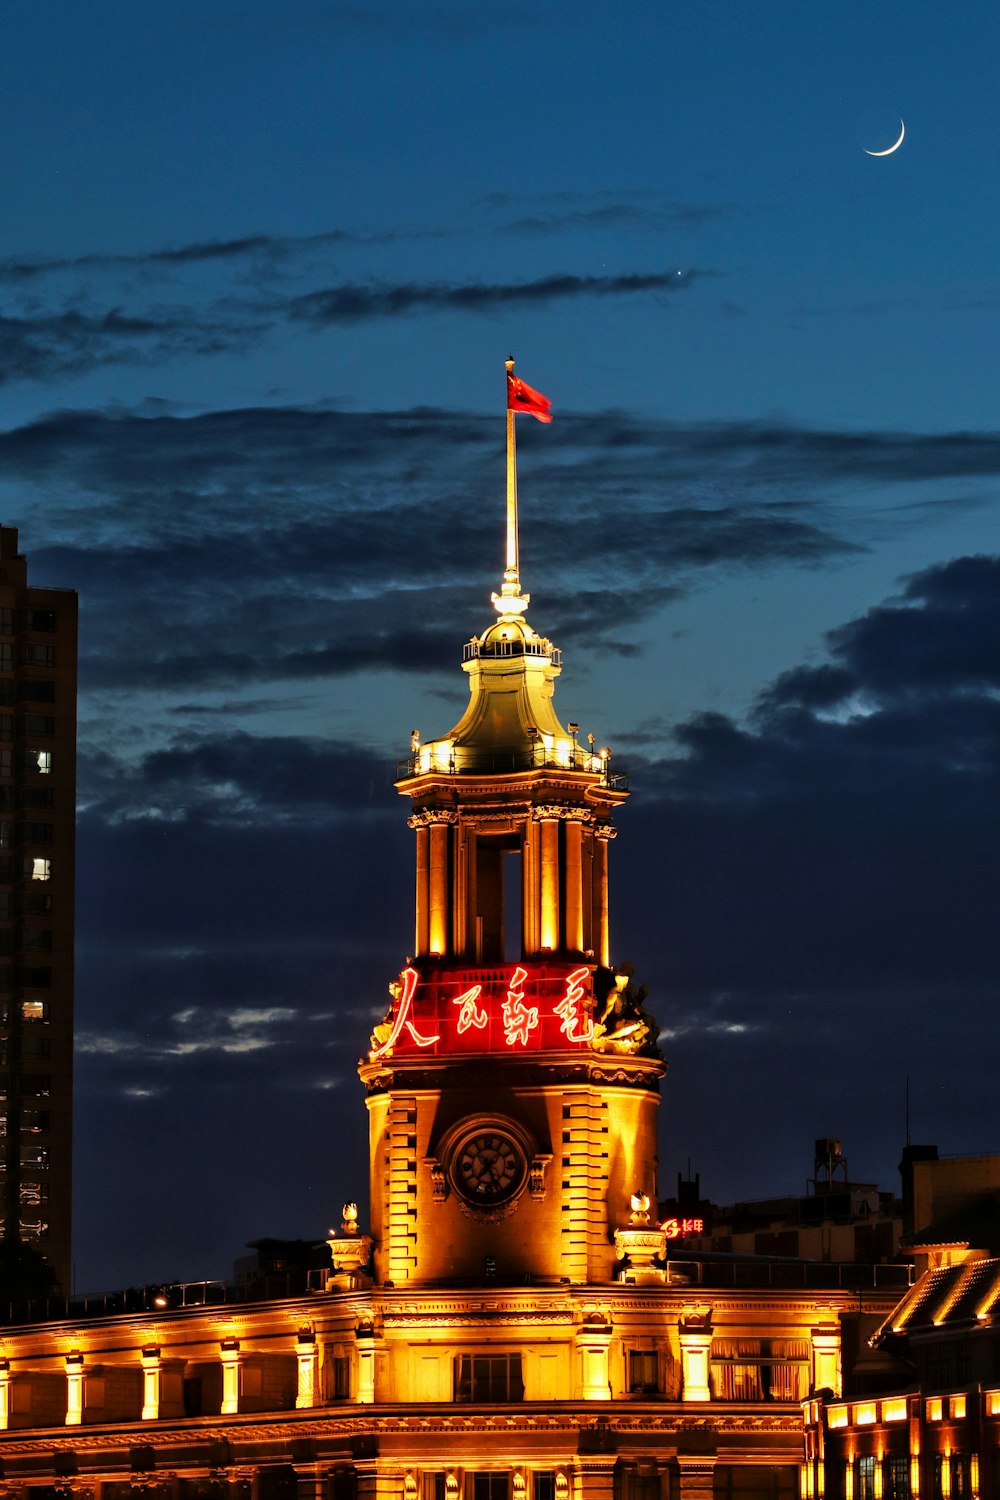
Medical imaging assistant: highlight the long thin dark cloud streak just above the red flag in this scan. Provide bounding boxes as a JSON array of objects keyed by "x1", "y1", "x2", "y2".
[{"x1": 288, "y1": 270, "x2": 705, "y2": 327}]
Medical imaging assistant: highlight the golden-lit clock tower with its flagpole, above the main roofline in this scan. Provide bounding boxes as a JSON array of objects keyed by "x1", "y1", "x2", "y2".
[{"x1": 360, "y1": 365, "x2": 664, "y2": 1286}]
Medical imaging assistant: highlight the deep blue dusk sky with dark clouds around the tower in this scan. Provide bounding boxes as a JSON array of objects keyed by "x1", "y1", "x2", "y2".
[{"x1": 0, "y1": 0, "x2": 1000, "y2": 1290}]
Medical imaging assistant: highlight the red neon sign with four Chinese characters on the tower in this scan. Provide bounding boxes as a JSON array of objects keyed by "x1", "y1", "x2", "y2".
[{"x1": 369, "y1": 962, "x2": 594, "y2": 1062}]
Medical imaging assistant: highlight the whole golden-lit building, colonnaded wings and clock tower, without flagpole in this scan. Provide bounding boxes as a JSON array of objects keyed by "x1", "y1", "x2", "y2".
[{"x1": 0, "y1": 429, "x2": 895, "y2": 1500}]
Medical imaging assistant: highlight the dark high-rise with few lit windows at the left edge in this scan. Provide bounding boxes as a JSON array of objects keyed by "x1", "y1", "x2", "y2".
[{"x1": 0, "y1": 527, "x2": 76, "y2": 1290}]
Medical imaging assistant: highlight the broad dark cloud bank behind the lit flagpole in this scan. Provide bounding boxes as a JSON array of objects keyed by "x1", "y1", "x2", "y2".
[{"x1": 0, "y1": 408, "x2": 856, "y2": 689}]
